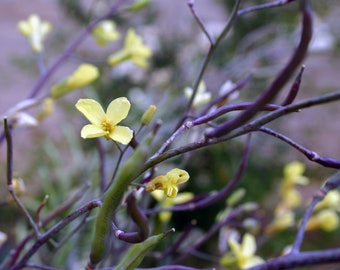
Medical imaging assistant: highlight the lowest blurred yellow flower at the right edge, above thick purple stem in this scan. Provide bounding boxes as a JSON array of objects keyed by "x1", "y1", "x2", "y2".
[{"x1": 306, "y1": 209, "x2": 339, "y2": 232}]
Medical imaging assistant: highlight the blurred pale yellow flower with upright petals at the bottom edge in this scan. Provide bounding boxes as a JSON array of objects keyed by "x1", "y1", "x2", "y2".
[{"x1": 226, "y1": 233, "x2": 263, "y2": 269}]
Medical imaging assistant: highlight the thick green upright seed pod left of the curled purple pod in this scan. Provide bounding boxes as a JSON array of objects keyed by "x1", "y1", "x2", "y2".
[{"x1": 89, "y1": 134, "x2": 153, "y2": 267}]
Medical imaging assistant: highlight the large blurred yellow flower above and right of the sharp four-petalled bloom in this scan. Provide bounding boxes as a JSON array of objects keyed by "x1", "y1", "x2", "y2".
[{"x1": 107, "y1": 29, "x2": 152, "y2": 68}]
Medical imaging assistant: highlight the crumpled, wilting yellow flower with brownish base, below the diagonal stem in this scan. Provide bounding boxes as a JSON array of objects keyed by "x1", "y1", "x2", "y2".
[{"x1": 145, "y1": 168, "x2": 189, "y2": 198}]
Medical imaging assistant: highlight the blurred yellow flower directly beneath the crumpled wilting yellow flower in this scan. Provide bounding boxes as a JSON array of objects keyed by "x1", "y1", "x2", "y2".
[{"x1": 151, "y1": 190, "x2": 194, "y2": 223}]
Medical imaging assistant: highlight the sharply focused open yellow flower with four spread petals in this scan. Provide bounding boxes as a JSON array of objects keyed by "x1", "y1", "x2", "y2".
[{"x1": 76, "y1": 97, "x2": 133, "y2": 144}]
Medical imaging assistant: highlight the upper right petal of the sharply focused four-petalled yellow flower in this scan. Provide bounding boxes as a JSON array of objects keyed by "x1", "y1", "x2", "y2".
[{"x1": 106, "y1": 97, "x2": 132, "y2": 125}]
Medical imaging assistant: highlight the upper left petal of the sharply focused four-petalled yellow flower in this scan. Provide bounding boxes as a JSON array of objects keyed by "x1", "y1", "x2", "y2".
[{"x1": 76, "y1": 99, "x2": 105, "y2": 126}]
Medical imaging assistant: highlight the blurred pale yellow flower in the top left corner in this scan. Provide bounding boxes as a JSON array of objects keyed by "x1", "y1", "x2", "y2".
[{"x1": 18, "y1": 14, "x2": 52, "y2": 53}]
